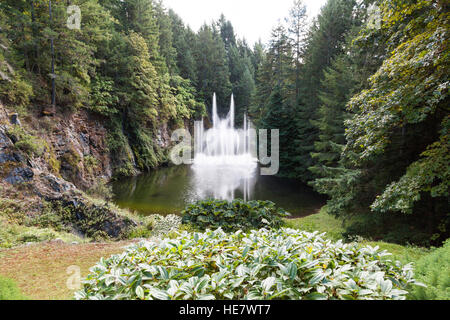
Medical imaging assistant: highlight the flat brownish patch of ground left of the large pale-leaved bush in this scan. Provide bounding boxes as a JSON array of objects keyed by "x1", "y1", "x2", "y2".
[{"x1": 0, "y1": 241, "x2": 139, "y2": 300}]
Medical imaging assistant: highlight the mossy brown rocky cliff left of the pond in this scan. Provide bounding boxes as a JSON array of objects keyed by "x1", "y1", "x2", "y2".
[{"x1": 0, "y1": 103, "x2": 178, "y2": 242}]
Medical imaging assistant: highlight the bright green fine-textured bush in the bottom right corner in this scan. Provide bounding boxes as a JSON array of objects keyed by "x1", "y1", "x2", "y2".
[{"x1": 410, "y1": 240, "x2": 450, "y2": 300}]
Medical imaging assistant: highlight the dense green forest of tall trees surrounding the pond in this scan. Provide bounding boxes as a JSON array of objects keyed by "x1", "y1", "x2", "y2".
[{"x1": 0, "y1": 0, "x2": 450, "y2": 245}]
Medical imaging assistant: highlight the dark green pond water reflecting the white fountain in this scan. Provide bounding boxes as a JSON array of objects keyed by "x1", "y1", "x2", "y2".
[{"x1": 113, "y1": 166, "x2": 325, "y2": 217}]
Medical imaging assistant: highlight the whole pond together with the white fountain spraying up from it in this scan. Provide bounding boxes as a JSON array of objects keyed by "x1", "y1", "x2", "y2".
[{"x1": 110, "y1": 95, "x2": 324, "y2": 217}]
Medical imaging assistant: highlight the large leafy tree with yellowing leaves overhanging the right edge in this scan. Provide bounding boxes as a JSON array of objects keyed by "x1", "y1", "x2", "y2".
[{"x1": 322, "y1": 1, "x2": 450, "y2": 244}]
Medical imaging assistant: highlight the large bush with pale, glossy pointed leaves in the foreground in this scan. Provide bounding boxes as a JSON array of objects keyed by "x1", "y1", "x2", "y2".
[{"x1": 75, "y1": 228, "x2": 415, "y2": 300}]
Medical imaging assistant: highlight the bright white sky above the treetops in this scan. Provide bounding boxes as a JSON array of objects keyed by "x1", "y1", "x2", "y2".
[{"x1": 163, "y1": 0, "x2": 326, "y2": 45}]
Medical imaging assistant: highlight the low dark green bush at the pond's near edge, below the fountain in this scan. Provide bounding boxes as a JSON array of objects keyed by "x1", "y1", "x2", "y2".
[{"x1": 182, "y1": 199, "x2": 289, "y2": 231}]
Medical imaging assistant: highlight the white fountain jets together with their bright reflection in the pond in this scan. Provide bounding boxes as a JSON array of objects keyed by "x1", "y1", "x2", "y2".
[{"x1": 192, "y1": 94, "x2": 258, "y2": 200}]
